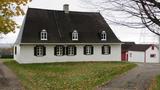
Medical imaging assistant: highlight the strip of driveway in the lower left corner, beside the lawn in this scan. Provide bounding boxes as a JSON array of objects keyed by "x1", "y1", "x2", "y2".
[{"x1": 0, "y1": 61, "x2": 23, "y2": 90}]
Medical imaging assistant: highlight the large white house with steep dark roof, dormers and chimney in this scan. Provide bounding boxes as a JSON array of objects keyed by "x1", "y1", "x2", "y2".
[{"x1": 14, "y1": 4, "x2": 121, "y2": 63}]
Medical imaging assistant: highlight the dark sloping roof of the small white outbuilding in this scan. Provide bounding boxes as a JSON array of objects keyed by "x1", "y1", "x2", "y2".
[{"x1": 129, "y1": 44, "x2": 151, "y2": 51}]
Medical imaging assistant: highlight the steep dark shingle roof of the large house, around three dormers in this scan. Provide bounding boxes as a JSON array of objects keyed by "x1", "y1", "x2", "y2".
[{"x1": 19, "y1": 8, "x2": 121, "y2": 43}]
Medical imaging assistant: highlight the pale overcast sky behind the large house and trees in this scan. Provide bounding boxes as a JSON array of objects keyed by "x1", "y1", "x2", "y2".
[{"x1": 0, "y1": 0, "x2": 158, "y2": 43}]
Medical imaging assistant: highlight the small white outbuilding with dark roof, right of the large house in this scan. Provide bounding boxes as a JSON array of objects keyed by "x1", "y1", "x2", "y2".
[{"x1": 122, "y1": 44, "x2": 160, "y2": 63}]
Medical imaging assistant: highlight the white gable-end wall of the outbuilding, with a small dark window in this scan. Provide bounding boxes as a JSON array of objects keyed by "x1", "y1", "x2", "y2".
[{"x1": 146, "y1": 47, "x2": 159, "y2": 63}]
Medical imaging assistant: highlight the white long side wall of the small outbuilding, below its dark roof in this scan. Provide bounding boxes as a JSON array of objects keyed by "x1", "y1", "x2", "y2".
[{"x1": 128, "y1": 51, "x2": 145, "y2": 62}]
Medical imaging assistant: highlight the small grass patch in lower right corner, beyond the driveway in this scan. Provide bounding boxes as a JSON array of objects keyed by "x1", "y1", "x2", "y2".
[{"x1": 150, "y1": 75, "x2": 160, "y2": 90}]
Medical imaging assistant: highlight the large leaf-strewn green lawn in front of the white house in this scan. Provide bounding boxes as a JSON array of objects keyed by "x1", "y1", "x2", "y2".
[{"x1": 4, "y1": 61, "x2": 136, "y2": 90}]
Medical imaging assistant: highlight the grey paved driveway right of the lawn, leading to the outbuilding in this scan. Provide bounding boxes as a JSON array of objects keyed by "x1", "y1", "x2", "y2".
[{"x1": 98, "y1": 63, "x2": 160, "y2": 90}]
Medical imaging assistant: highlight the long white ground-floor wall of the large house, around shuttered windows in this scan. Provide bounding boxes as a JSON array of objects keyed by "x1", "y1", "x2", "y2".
[{"x1": 15, "y1": 44, "x2": 121, "y2": 63}]
